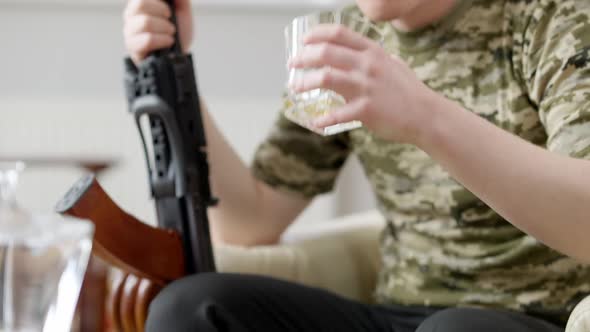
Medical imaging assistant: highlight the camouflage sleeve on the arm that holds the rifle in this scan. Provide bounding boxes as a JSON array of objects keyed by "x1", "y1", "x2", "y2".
[{"x1": 252, "y1": 97, "x2": 350, "y2": 197}]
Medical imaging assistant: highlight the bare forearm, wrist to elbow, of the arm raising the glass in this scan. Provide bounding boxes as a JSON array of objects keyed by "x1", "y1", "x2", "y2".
[{"x1": 418, "y1": 93, "x2": 590, "y2": 261}]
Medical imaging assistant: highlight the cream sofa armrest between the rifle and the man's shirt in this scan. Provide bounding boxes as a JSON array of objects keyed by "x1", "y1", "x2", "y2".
[{"x1": 215, "y1": 211, "x2": 384, "y2": 302}]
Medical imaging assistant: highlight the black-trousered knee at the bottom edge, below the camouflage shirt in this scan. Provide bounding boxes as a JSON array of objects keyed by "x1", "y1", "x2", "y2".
[{"x1": 416, "y1": 308, "x2": 496, "y2": 332}]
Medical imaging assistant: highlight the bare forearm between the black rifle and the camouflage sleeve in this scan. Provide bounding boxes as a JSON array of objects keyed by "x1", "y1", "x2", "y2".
[{"x1": 202, "y1": 103, "x2": 306, "y2": 245}]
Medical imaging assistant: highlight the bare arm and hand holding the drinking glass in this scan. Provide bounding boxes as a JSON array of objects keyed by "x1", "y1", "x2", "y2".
[{"x1": 291, "y1": 26, "x2": 590, "y2": 262}]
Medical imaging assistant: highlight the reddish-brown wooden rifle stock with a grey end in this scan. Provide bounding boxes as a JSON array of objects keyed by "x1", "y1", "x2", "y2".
[{"x1": 56, "y1": 175, "x2": 185, "y2": 286}]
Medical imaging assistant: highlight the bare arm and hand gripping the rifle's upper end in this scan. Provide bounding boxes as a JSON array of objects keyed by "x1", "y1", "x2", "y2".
[{"x1": 124, "y1": 0, "x2": 309, "y2": 245}]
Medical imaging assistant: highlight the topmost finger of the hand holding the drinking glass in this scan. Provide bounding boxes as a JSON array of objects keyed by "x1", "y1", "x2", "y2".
[{"x1": 303, "y1": 24, "x2": 372, "y2": 51}]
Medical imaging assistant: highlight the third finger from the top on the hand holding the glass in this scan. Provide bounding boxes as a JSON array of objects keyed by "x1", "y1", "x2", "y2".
[{"x1": 291, "y1": 68, "x2": 366, "y2": 100}]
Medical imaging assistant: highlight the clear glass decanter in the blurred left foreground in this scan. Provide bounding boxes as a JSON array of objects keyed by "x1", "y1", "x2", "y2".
[{"x1": 0, "y1": 162, "x2": 94, "y2": 332}]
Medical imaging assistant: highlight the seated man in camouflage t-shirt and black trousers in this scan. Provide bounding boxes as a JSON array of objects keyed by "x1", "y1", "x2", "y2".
[{"x1": 123, "y1": 0, "x2": 590, "y2": 332}]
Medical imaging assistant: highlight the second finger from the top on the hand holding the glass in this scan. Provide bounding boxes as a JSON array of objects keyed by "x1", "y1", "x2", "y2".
[{"x1": 289, "y1": 43, "x2": 360, "y2": 70}]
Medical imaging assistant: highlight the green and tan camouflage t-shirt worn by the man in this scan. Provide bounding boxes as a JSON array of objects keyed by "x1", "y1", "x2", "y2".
[{"x1": 253, "y1": 0, "x2": 590, "y2": 320}]
